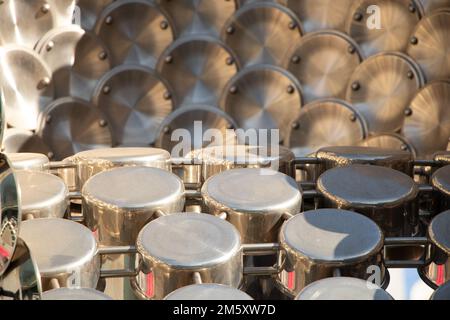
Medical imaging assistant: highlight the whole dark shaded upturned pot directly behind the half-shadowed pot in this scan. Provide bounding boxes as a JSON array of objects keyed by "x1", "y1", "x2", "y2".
[{"x1": 317, "y1": 164, "x2": 418, "y2": 237}]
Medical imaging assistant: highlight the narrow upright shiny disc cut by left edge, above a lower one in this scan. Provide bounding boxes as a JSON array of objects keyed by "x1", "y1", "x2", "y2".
[{"x1": 0, "y1": 154, "x2": 22, "y2": 276}]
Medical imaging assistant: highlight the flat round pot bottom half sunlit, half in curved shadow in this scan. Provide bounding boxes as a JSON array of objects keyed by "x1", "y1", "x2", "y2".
[{"x1": 280, "y1": 209, "x2": 383, "y2": 265}]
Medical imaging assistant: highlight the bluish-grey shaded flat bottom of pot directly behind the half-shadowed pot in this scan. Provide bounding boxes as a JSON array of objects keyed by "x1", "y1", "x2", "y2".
[{"x1": 317, "y1": 164, "x2": 418, "y2": 208}]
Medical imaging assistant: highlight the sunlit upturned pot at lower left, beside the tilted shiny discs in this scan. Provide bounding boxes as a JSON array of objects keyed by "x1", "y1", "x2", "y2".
[{"x1": 20, "y1": 218, "x2": 100, "y2": 291}]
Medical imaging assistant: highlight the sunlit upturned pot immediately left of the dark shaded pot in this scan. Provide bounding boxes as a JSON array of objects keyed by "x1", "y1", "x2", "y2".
[{"x1": 202, "y1": 169, "x2": 302, "y2": 243}]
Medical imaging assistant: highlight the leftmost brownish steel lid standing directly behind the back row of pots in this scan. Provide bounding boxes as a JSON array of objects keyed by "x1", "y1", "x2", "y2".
[{"x1": 38, "y1": 98, "x2": 112, "y2": 160}]
